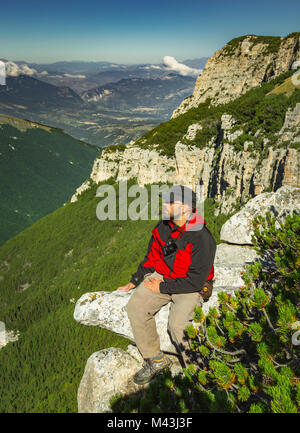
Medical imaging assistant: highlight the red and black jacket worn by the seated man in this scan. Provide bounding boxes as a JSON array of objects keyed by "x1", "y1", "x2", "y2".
[{"x1": 131, "y1": 210, "x2": 216, "y2": 294}]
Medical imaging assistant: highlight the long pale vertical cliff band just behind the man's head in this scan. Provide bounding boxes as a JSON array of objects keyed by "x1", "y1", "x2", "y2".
[{"x1": 71, "y1": 103, "x2": 300, "y2": 214}]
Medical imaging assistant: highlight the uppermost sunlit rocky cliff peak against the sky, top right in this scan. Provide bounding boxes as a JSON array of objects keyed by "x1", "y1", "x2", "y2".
[{"x1": 172, "y1": 33, "x2": 300, "y2": 117}]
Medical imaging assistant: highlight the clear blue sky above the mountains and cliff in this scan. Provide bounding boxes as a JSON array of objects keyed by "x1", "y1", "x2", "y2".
[{"x1": 0, "y1": 0, "x2": 300, "y2": 63}]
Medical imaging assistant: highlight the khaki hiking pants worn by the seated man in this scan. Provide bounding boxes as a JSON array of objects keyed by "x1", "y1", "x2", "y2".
[{"x1": 125, "y1": 272, "x2": 203, "y2": 366}]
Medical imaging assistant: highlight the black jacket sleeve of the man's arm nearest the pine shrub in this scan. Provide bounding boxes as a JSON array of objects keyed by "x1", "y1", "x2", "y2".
[{"x1": 159, "y1": 231, "x2": 217, "y2": 294}]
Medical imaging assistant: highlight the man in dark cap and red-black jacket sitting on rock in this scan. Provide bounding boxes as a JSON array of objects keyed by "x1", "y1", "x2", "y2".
[{"x1": 117, "y1": 185, "x2": 216, "y2": 385}]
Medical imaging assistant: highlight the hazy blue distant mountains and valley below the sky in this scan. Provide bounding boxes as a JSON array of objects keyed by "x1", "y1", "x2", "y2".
[{"x1": 0, "y1": 60, "x2": 204, "y2": 147}]
